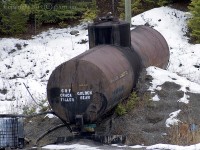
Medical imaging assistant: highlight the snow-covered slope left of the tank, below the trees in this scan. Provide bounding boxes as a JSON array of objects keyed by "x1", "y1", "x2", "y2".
[{"x1": 0, "y1": 24, "x2": 89, "y2": 113}]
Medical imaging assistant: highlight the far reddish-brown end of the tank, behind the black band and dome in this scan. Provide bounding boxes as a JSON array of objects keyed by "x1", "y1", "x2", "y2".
[{"x1": 131, "y1": 26, "x2": 169, "y2": 69}]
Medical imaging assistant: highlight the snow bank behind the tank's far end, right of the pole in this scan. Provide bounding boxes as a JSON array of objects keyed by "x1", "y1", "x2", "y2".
[{"x1": 132, "y1": 7, "x2": 200, "y2": 84}]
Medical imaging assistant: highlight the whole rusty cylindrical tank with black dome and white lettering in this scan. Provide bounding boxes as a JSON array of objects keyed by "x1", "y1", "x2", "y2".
[{"x1": 47, "y1": 18, "x2": 169, "y2": 132}]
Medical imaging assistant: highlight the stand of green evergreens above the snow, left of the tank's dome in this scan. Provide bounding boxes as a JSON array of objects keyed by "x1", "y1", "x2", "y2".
[{"x1": 0, "y1": 0, "x2": 96, "y2": 35}]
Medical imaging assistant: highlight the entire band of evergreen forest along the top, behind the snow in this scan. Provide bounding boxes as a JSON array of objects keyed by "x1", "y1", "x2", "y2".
[{"x1": 0, "y1": 0, "x2": 200, "y2": 43}]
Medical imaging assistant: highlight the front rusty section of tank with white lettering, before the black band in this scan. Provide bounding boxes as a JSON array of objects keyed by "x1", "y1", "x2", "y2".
[{"x1": 47, "y1": 45, "x2": 139, "y2": 124}]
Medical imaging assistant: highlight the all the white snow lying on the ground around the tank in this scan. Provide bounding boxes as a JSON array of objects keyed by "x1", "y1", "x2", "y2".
[{"x1": 0, "y1": 7, "x2": 200, "y2": 150}]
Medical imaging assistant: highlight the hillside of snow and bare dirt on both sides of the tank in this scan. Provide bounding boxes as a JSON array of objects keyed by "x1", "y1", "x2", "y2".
[{"x1": 0, "y1": 7, "x2": 200, "y2": 149}]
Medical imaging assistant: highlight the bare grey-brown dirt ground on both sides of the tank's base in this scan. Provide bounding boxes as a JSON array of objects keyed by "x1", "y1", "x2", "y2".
[{"x1": 24, "y1": 71, "x2": 200, "y2": 148}]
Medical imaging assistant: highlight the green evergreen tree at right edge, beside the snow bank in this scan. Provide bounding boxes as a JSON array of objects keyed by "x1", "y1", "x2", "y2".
[{"x1": 188, "y1": 0, "x2": 200, "y2": 43}]
